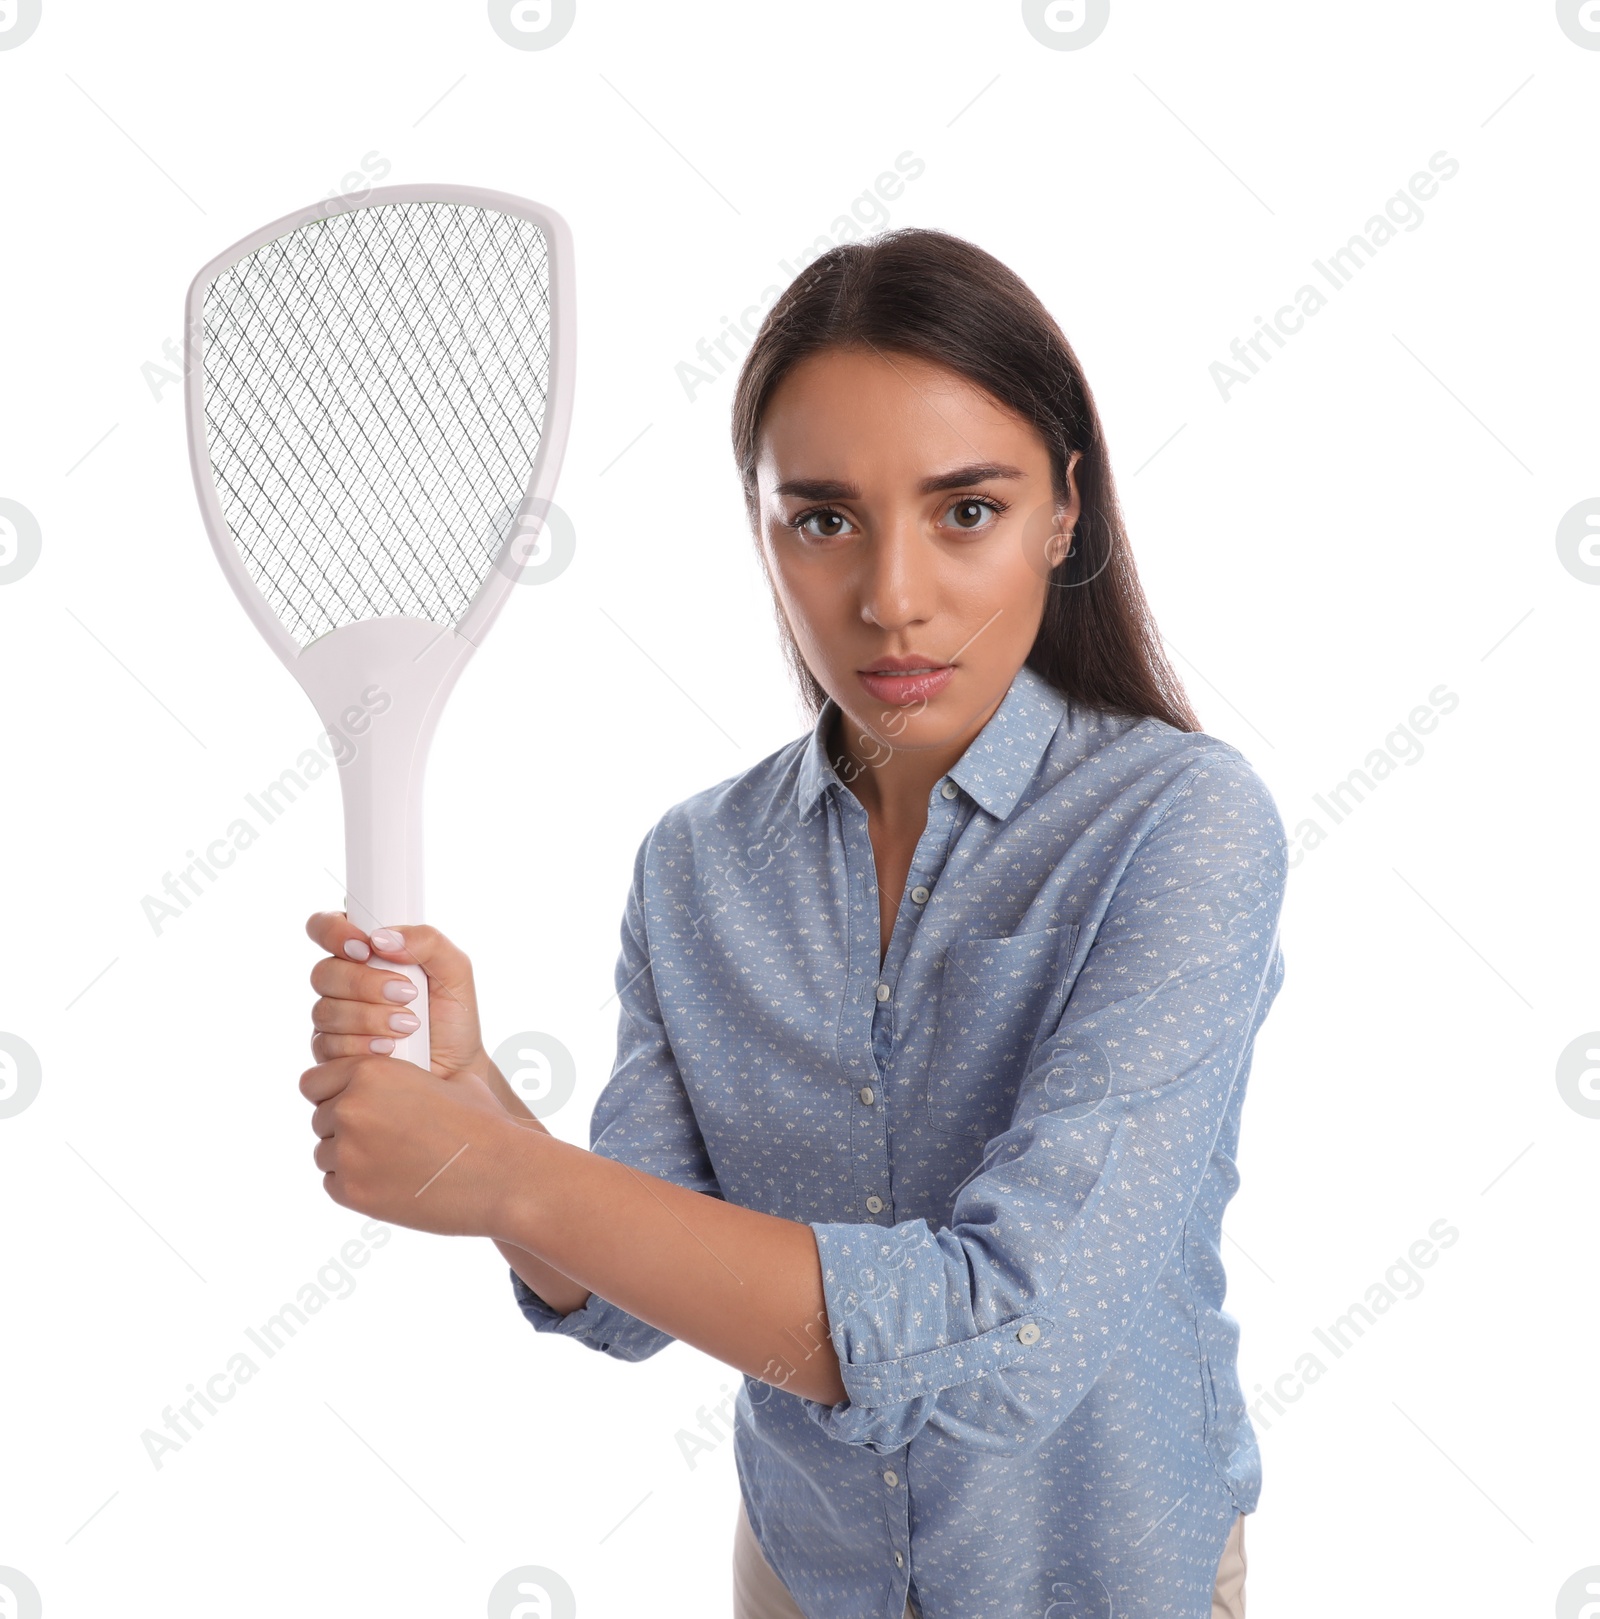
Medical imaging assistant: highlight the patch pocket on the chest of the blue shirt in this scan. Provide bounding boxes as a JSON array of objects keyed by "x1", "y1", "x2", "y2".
[{"x1": 928, "y1": 923, "x2": 1079, "y2": 1140}]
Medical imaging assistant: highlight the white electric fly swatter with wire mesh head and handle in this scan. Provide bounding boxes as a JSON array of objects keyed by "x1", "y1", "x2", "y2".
[{"x1": 185, "y1": 186, "x2": 573, "y2": 1069}]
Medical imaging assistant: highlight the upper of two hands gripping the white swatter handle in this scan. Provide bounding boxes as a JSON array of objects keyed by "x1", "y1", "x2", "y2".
[{"x1": 306, "y1": 911, "x2": 492, "y2": 1087}]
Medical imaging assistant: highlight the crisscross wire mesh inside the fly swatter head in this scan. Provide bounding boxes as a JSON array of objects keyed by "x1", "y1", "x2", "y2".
[{"x1": 202, "y1": 202, "x2": 551, "y2": 646}]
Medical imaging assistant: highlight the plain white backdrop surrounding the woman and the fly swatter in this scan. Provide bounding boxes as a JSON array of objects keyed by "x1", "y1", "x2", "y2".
[{"x1": 0, "y1": 0, "x2": 1600, "y2": 1619}]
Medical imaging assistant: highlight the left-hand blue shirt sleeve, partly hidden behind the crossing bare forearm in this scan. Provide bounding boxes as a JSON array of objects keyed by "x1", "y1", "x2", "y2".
[{"x1": 512, "y1": 815, "x2": 722, "y2": 1360}]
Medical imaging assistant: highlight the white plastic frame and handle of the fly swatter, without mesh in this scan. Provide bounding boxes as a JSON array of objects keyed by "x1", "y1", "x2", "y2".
[{"x1": 183, "y1": 185, "x2": 577, "y2": 1069}]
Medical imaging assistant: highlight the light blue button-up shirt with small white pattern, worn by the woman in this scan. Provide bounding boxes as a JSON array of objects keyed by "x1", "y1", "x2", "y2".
[{"x1": 512, "y1": 667, "x2": 1287, "y2": 1619}]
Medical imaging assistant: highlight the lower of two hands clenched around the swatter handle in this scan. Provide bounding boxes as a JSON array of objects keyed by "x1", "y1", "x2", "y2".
[{"x1": 300, "y1": 1056, "x2": 520, "y2": 1237}]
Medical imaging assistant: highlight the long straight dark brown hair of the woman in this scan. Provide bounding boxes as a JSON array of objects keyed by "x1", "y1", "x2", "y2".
[{"x1": 734, "y1": 228, "x2": 1200, "y2": 730}]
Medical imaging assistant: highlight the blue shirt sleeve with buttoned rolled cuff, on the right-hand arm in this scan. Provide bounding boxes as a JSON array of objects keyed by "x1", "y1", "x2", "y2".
[{"x1": 805, "y1": 746, "x2": 1287, "y2": 1454}]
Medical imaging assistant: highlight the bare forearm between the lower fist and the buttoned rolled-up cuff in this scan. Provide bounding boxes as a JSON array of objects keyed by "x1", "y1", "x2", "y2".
[{"x1": 494, "y1": 1130, "x2": 845, "y2": 1405}]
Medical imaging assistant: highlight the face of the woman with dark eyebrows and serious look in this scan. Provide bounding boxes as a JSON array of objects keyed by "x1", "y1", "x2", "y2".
[{"x1": 756, "y1": 348, "x2": 1079, "y2": 763}]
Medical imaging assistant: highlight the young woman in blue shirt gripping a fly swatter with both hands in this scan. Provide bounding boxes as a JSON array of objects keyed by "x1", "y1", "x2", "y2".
[{"x1": 301, "y1": 230, "x2": 1286, "y2": 1619}]
